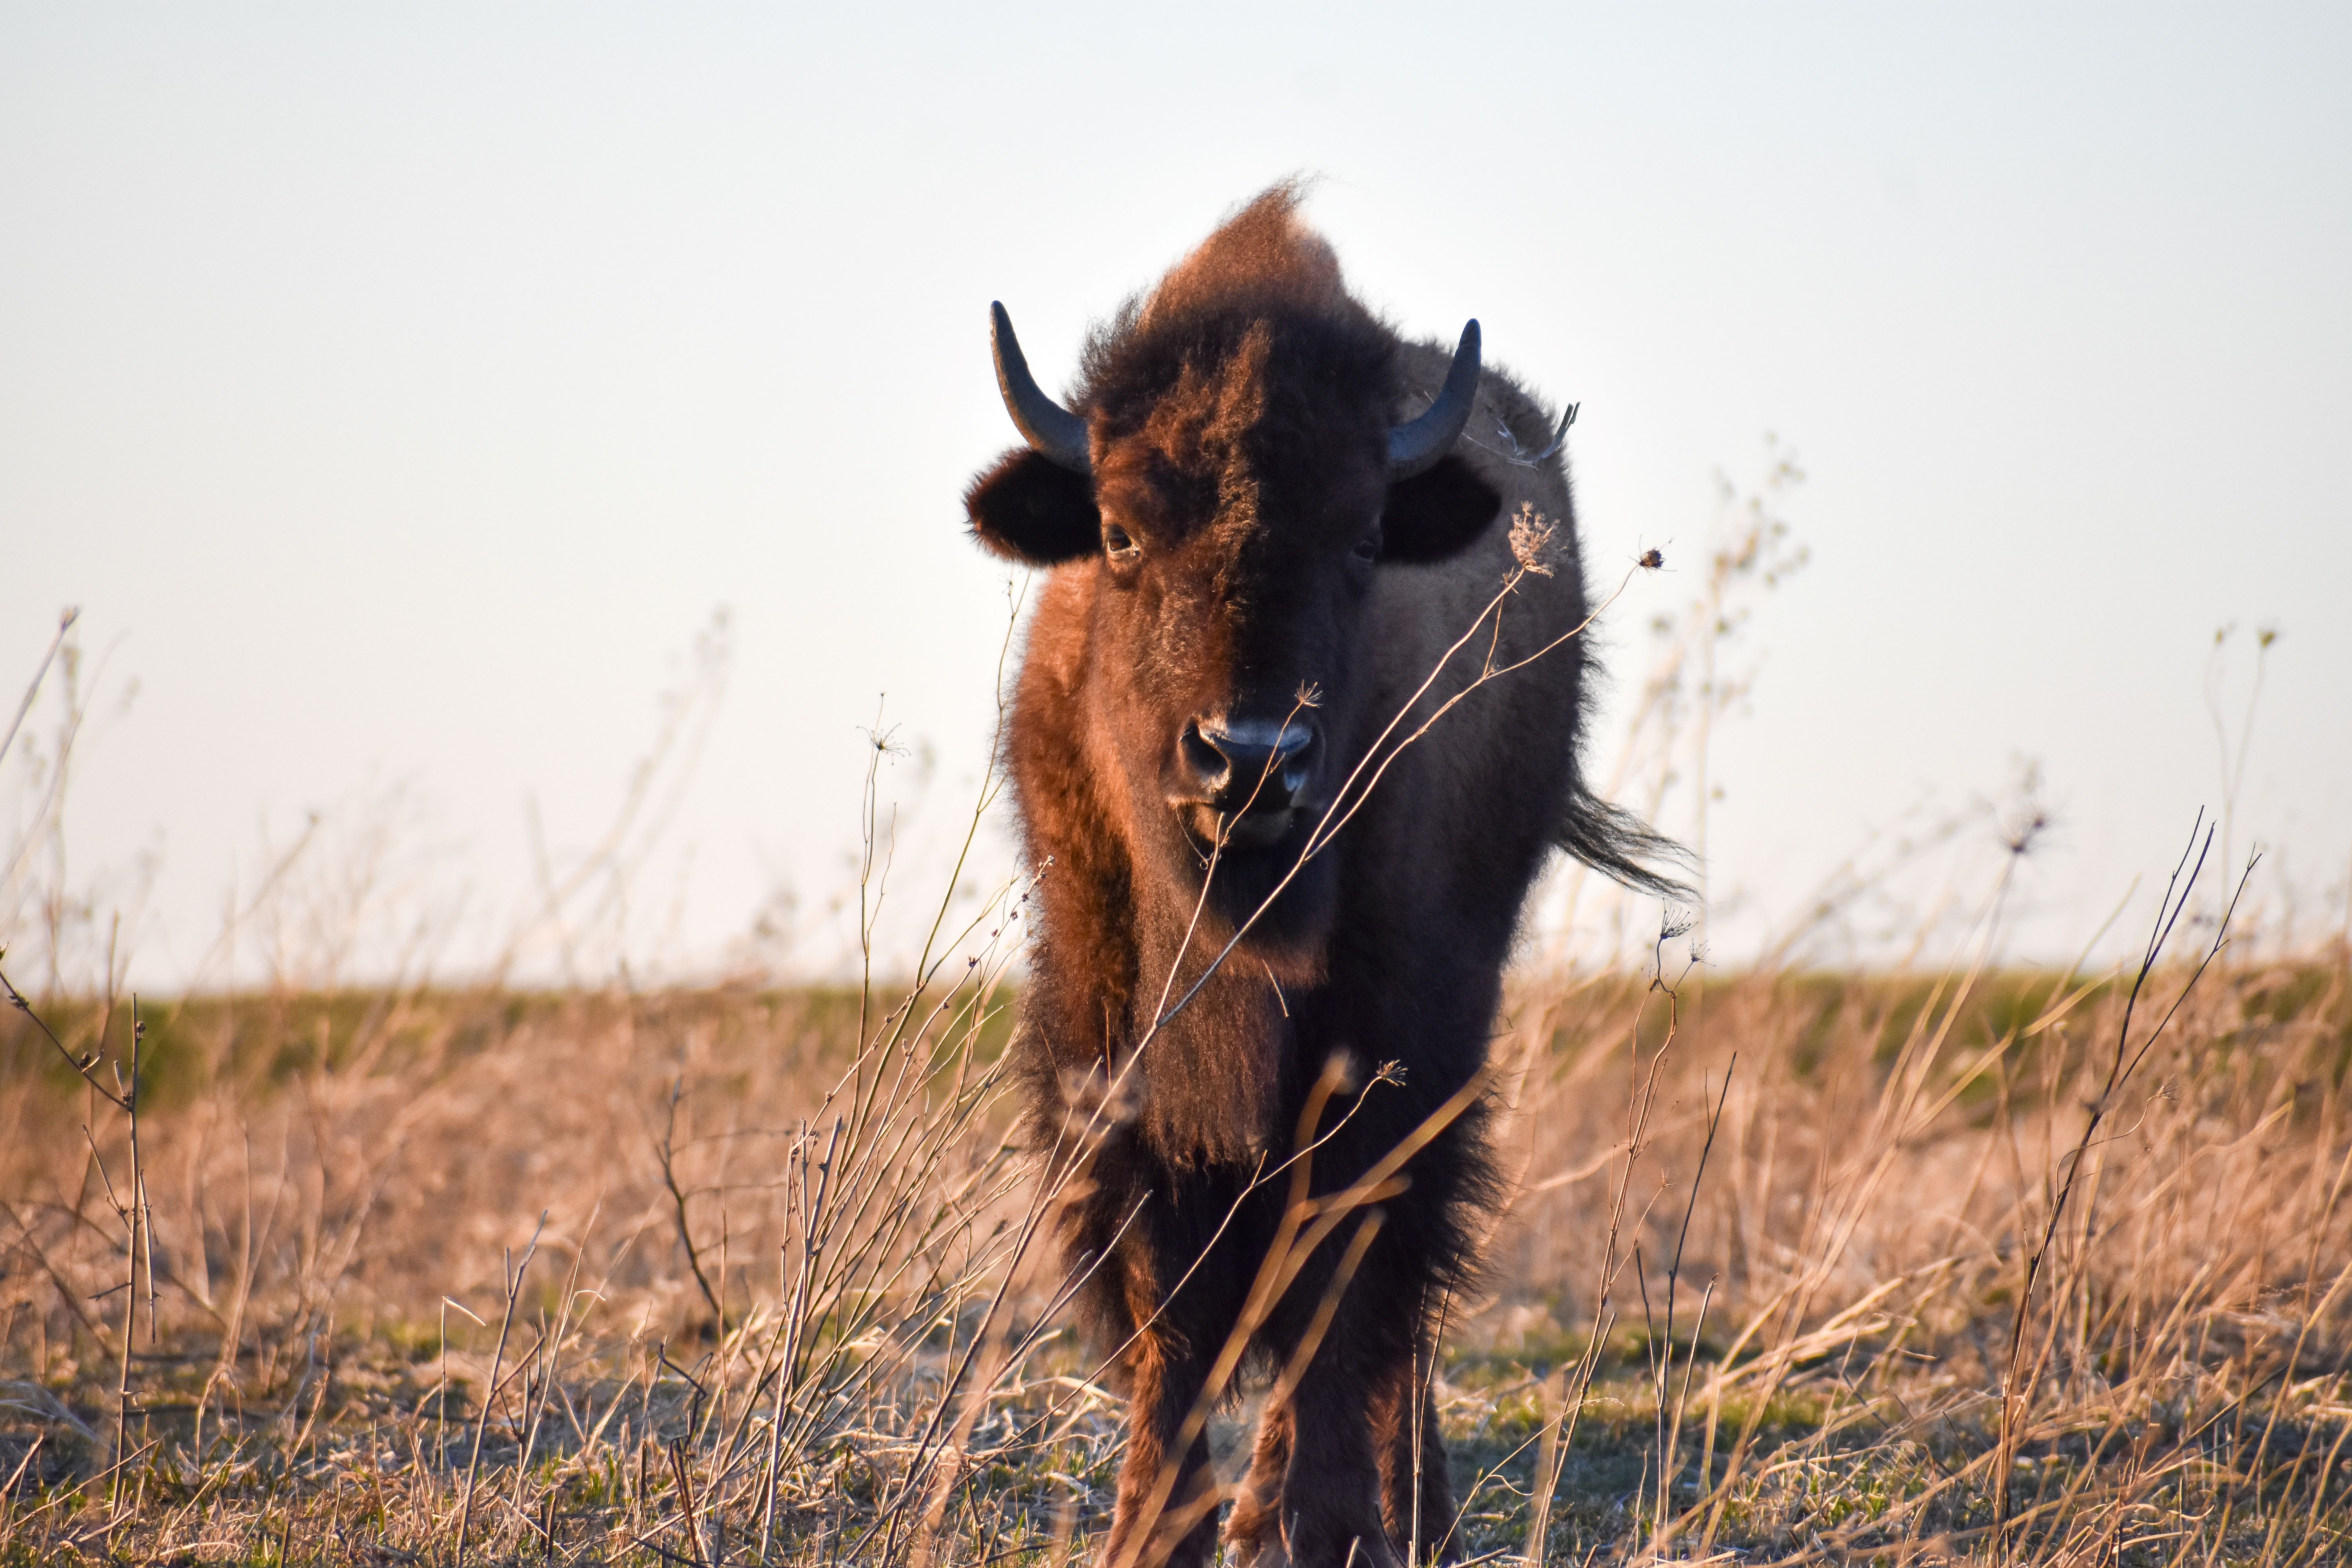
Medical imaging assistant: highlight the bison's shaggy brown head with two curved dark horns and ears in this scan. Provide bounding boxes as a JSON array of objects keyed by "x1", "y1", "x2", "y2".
[{"x1": 967, "y1": 191, "x2": 1501, "y2": 950}]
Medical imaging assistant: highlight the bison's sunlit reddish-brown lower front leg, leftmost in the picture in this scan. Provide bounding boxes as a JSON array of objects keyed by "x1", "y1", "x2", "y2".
[{"x1": 1098, "y1": 1338, "x2": 1221, "y2": 1568}]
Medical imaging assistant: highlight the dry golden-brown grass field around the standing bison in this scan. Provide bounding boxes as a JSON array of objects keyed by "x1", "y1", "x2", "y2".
[{"x1": 0, "y1": 922, "x2": 2352, "y2": 1566}]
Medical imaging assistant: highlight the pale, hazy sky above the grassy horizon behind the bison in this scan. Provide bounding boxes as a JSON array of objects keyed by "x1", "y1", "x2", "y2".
[{"x1": 0, "y1": 5, "x2": 2352, "y2": 990}]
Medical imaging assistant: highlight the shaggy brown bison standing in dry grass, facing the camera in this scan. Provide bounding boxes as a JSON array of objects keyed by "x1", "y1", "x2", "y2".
[{"x1": 964, "y1": 186, "x2": 1670, "y2": 1568}]
